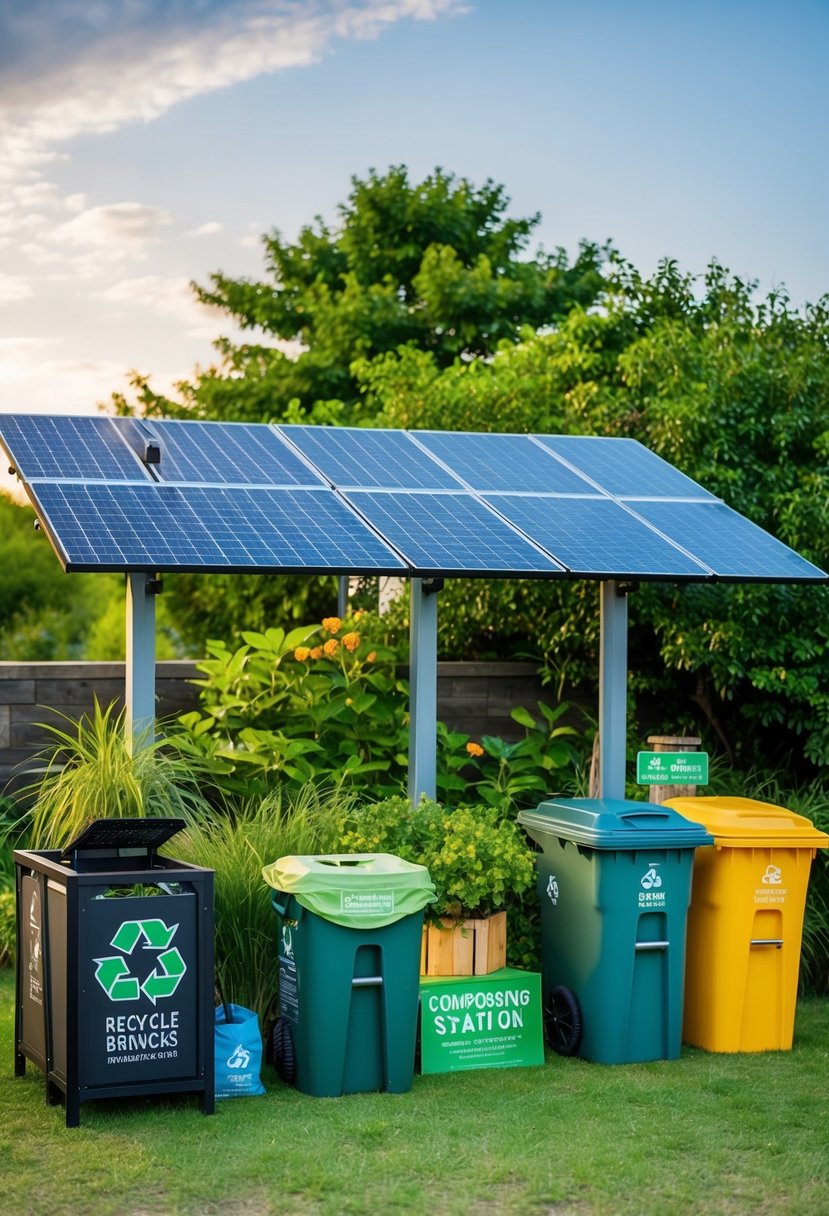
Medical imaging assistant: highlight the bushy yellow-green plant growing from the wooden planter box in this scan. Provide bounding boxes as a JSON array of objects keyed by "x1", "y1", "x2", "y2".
[{"x1": 339, "y1": 796, "x2": 535, "y2": 919}]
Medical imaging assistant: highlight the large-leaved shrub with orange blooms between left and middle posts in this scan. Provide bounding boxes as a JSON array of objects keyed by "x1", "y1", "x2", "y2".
[{"x1": 175, "y1": 614, "x2": 408, "y2": 793}]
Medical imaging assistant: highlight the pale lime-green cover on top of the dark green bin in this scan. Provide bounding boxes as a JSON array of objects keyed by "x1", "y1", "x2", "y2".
[{"x1": 263, "y1": 852, "x2": 438, "y2": 929}]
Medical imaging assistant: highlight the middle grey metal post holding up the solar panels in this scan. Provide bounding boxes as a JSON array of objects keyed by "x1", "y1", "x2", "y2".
[{"x1": 408, "y1": 579, "x2": 442, "y2": 804}]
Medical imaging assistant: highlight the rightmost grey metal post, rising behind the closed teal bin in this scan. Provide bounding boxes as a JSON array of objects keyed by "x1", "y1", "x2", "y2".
[{"x1": 599, "y1": 581, "x2": 627, "y2": 798}]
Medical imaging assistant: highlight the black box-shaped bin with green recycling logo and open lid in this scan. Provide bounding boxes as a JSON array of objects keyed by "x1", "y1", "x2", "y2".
[{"x1": 15, "y1": 818, "x2": 214, "y2": 1127}]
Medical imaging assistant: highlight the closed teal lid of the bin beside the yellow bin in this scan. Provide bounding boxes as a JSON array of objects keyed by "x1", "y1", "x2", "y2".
[{"x1": 518, "y1": 798, "x2": 714, "y2": 850}]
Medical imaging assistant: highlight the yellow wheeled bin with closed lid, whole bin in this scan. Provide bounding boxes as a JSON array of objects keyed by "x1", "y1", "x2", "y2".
[{"x1": 665, "y1": 796, "x2": 829, "y2": 1052}]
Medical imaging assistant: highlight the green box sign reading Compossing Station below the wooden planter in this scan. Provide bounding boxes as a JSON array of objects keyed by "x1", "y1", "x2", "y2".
[{"x1": 421, "y1": 967, "x2": 545, "y2": 1073}]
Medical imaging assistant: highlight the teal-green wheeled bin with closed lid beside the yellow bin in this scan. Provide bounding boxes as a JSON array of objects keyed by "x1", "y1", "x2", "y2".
[{"x1": 518, "y1": 798, "x2": 712, "y2": 1064}]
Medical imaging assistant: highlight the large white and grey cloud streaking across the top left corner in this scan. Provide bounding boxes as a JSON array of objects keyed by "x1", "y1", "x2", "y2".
[{"x1": 0, "y1": 0, "x2": 463, "y2": 180}]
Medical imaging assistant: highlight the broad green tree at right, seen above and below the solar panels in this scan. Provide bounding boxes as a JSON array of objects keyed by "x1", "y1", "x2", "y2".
[{"x1": 357, "y1": 259, "x2": 829, "y2": 762}]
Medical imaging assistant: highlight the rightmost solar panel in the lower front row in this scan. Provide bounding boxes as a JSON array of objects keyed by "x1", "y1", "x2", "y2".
[{"x1": 633, "y1": 501, "x2": 825, "y2": 582}]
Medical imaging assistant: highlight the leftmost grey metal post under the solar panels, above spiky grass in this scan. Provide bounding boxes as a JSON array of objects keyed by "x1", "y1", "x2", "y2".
[{"x1": 124, "y1": 572, "x2": 160, "y2": 751}]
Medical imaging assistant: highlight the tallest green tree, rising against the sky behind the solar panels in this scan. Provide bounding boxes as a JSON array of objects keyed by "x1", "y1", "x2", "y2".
[{"x1": 114, "y1": 165, "x2": 605, "y2": 422}]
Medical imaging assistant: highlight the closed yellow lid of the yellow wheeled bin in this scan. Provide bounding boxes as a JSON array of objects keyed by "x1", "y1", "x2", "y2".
[{"x1": 665, "y1": 794, "x2": 829, "y2": 849}]
